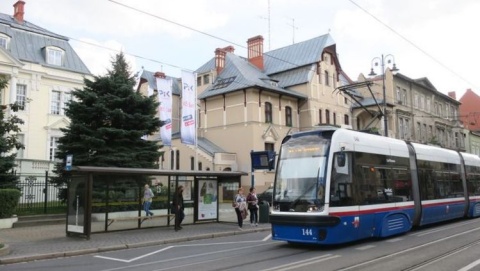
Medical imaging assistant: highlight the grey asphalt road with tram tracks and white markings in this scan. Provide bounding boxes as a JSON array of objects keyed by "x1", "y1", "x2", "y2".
[{"x1": 0, "y1": 219, "x2": 480, "y2": 271}]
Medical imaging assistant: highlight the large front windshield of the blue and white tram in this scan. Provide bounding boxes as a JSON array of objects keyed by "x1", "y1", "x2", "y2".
[{"x1": 273, "y1": 135, "x2": 330, "y2": 212}]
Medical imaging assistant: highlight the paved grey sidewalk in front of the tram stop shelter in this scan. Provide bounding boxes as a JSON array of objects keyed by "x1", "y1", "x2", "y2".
[{"x1": 0, "y1": 222, "x2": 271, "y2": 265}]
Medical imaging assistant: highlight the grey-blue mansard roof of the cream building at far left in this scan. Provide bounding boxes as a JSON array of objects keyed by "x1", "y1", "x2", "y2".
[{"x1": 0, "y1": 13, "x2": 90, "y2": 74}]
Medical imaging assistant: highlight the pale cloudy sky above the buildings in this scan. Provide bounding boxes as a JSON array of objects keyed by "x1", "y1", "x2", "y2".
[{"x1": 0, "y1": 0, "x2": 480, "y2": 99}]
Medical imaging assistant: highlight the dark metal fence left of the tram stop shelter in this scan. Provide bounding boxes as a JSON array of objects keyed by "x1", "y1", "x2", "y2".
[{"x1": 0, "y1": 171, "x2": 67, "y2": 215}]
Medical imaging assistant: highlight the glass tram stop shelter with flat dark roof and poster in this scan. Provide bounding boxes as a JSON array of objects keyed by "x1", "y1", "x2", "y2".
[{"x1": 66, "y1": 166, "x2": 248, "y2": 238}]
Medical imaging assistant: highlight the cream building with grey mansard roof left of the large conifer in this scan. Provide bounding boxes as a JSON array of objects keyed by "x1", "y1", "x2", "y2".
[{"x1": 0, "y1": 1, "x2": 90, "y2": 174}]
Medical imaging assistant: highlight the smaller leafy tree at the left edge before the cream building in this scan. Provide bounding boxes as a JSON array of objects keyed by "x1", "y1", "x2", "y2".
[{"x1": 0, "y1": 77, "x2": 25, "y2": 188}]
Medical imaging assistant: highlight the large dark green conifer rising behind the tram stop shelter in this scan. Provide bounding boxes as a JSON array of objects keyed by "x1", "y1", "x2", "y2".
[{"x1": 53, "y1": 53, "x2": 163, "y2": 189}]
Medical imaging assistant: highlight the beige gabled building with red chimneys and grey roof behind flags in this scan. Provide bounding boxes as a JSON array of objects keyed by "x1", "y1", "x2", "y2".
[{"x1": 140, "y1": 34, "x2": 351, "y2": 191}]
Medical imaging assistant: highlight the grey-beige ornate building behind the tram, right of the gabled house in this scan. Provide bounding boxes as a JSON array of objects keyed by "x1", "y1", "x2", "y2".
[{"x1": 353, "y1": 69, "x2": 465, "y2": 151}]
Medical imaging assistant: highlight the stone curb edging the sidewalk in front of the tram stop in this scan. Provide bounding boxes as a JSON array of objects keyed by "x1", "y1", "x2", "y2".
[{"x1": 0, "y1": 227, "x2": 271, "y2": 265}]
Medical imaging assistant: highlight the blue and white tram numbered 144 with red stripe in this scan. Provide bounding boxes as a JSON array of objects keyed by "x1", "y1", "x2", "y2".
[{"x1": 270, "y1": 127, "x2": 480, "y2": 244}]
